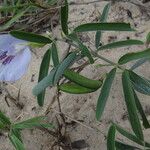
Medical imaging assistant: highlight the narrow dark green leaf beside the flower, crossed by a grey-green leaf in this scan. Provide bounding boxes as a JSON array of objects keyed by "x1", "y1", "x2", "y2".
[{"x1": 37, "y1": 49, "x2": 51, "y2": 106}]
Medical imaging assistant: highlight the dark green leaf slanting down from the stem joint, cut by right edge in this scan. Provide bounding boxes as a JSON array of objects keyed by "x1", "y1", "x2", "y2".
[{"x1": 129, "y1": 71, "x2": 150, "y2": 95}]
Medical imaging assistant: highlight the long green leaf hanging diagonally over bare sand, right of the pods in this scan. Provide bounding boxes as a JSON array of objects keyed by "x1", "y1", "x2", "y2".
[{"x1": 96, "y1": 68, "x2": 116, "y2": 120}]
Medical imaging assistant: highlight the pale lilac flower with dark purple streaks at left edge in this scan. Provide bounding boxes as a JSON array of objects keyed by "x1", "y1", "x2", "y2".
[{"x1": 0, "y1": 34, "x2": 31, "y2": 81}]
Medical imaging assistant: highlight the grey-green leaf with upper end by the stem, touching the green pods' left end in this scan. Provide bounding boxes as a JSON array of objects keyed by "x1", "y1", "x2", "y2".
[{"x1": 53, "y1": 52, "x2": 77, "y2": 85}]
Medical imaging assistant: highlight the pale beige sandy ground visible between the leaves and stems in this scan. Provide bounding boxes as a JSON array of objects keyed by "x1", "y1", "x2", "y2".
[{"x1": 0, "y1": 0, "x2": 150, "y2": 150}]
